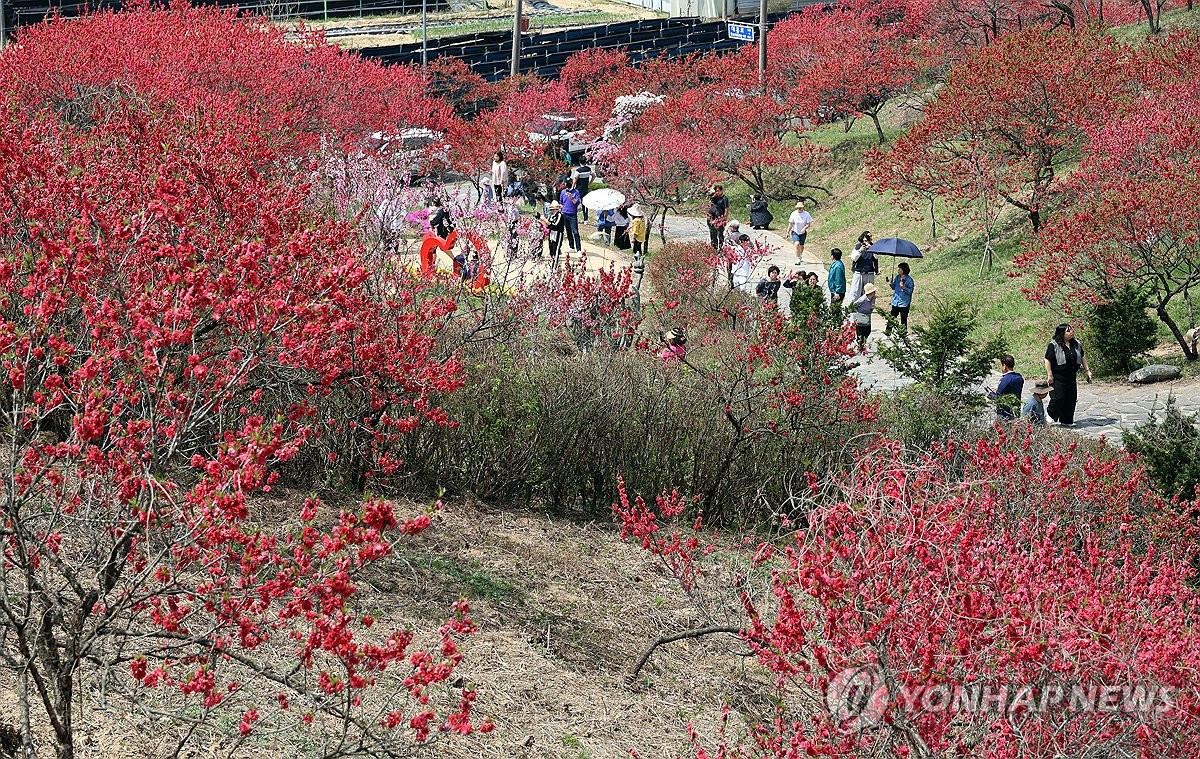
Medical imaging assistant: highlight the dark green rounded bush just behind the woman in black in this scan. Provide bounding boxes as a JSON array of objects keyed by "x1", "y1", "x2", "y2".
[{"x1": 1084, "y1": 285, "x2": 1158, "y2": 375}]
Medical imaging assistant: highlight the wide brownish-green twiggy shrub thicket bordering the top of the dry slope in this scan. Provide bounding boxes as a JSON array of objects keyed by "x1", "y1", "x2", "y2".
[{"x1": 404, "y1": 329, "x2": 873, "y2": 520}]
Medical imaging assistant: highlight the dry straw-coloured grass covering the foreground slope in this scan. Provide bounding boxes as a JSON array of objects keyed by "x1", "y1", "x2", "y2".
[{"x1": 0, "y1": 497, "x2": 769, "y2": 759}]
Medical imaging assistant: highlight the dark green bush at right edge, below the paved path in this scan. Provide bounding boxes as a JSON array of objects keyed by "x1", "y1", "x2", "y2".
[{"x1": 1122, "y1": 395, "x2": 1200, "y2": 500}]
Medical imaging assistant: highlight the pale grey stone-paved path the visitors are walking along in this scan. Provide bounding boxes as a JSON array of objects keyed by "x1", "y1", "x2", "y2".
[{"x1": 666, "y1": 216, "x2": 1200, "y2": 444}]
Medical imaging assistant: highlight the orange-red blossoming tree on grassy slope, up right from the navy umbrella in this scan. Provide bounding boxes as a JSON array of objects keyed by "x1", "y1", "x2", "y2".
[{"x1": 868, "y1": 28, "x2": 1128, "y2": 233}]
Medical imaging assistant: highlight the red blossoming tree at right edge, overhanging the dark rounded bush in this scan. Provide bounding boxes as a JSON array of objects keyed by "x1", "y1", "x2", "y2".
[{"x1": 1016, "y1": 34, "x2": 1200, "y2": 360}]
